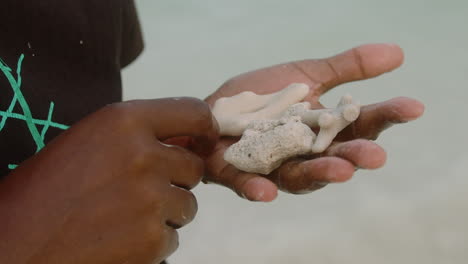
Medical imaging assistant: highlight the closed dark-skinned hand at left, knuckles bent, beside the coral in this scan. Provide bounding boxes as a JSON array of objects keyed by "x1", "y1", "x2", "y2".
[{"x1": 0, "y1": 98, "x2": 218, "y2": 264}]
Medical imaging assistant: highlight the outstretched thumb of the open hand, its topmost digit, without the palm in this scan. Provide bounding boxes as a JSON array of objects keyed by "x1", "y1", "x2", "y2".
[{"x1": 293, "y1": 44, "x2": 404, "y2": 94}]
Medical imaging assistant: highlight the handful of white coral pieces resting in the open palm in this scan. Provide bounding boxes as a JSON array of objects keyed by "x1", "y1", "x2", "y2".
[{"x1": 213, "y1": 84, "x2": 360, "y2": 174}]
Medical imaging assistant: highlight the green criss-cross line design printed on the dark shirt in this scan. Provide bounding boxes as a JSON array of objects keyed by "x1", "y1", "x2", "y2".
[{"x1": 0, "y1": 54, "x2": 69, "y2": 169}]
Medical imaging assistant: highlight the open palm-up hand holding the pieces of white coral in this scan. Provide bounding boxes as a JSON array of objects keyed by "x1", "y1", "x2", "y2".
[{"x1": 204, "y1": 44, "x2": 424, "y2": 202}]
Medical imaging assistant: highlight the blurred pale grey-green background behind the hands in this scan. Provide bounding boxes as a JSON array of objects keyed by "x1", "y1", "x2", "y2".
[{"x1": 124, "y1": 0, "x2": 468, "y2": 264}]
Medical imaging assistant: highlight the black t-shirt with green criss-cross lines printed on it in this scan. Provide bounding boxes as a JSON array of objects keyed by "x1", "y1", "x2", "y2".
[{"x1": 0, "y1": 0, "x2": 143, "y2": 178}]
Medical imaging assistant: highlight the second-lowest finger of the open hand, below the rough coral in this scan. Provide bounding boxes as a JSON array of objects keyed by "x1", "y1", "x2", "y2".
[{"x1": 269, "y1": 157, "x2": 355, "y2": 194}]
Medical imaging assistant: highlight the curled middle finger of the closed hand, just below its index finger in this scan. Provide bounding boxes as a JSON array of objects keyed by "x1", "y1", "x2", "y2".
[{"x1": 161, "y1": 145, "x2": 204, "y2": 190}]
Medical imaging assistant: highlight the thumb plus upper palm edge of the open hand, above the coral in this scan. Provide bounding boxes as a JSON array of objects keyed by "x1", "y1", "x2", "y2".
[{"x1": 206, "y1": 44, "x2": 404, "y2": 105}]
